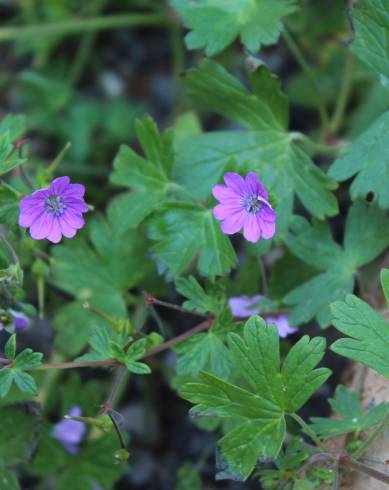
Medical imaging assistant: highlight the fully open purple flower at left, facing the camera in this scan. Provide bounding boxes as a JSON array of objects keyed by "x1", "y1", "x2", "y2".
[{"x1": 19, "y1": 177, "x2": 88, "y2": 243}]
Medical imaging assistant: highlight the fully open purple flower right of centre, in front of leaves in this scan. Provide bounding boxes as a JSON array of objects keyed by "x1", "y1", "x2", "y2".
[{"x1": 212, "y1": 172, "x2": 277, "y2": 243}]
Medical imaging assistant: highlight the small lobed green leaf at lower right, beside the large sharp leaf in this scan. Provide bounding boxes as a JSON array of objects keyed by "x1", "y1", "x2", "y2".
[{"x1": 311, "y1": 385, "x2": 389, "y2": 438}]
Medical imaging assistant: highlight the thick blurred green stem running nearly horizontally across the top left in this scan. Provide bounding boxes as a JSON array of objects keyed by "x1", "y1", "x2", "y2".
[{"x1": 0, "y1": 13, "x2": 171, "y2": 42}]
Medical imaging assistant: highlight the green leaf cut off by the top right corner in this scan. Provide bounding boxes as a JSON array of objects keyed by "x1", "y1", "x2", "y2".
[{"x1": 351, "y1": 0, "x2": 389, "y2": 87}]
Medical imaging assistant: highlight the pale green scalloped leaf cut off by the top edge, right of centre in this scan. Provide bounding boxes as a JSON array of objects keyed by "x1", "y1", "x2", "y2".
[{"x1": 171, "y1": 0, "x2": 296, "y2": 56}]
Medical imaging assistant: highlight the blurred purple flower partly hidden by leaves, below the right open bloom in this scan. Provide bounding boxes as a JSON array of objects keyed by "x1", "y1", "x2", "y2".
[{"x1": 228, "y1": 294, "x2": 297, "y2": 339}]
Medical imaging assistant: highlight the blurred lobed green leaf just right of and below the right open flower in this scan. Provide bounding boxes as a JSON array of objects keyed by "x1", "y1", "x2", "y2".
[{"x1": 284, "y1": 202, "x2": 389, "y2": 327}]
